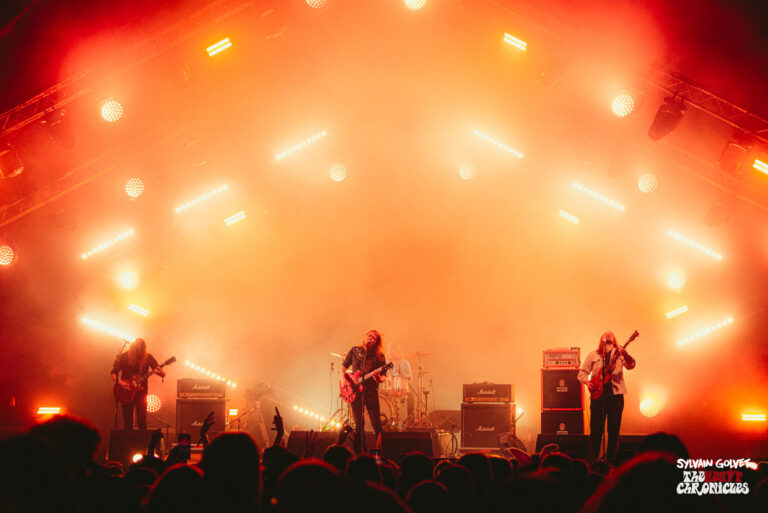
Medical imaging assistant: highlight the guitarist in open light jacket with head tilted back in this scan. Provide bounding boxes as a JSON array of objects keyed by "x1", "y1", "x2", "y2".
[{"x1": 578, "y1": 331, "x2": 635, "y2": 462}]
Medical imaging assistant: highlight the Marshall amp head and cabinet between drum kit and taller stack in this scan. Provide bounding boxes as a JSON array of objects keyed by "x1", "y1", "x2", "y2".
[{"x1": 461, "y1": 383, "x2": 515, "y2": 450}]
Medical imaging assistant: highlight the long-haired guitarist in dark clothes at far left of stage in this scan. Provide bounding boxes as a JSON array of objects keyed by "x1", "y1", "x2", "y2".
[{"x1": 111, "y1": 338, "x2": 165, "y2": 430}]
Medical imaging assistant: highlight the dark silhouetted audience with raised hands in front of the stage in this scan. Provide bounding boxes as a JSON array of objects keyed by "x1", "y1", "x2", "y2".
[{"x1": 0, "y1": 416, "x2": 768, "y2": 513}]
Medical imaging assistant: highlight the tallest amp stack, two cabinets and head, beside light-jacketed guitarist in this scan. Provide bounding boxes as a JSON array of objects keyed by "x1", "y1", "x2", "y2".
[{"x1": 541, "y1": 347, "x2": 584, "y2": 435}]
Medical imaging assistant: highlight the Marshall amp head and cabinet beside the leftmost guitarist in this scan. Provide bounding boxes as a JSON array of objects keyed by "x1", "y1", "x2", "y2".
[{"x1": 176, "y1": 378, "x2": 227, "y2": 443}]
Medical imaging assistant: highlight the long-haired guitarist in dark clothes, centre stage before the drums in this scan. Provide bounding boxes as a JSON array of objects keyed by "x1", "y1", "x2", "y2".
[{"x1": 341, "y1": 330, "x2": 386, "y2": 453}]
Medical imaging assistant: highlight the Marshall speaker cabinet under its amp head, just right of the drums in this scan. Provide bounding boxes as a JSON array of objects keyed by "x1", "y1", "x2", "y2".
[{"x1": 461, "y1": 403, "x2": 514, "y2": 448}]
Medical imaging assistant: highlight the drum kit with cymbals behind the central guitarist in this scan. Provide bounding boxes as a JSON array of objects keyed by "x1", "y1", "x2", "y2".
[{"x1": 330, "y1": 351, "x2": 432, "y2": 431}]
